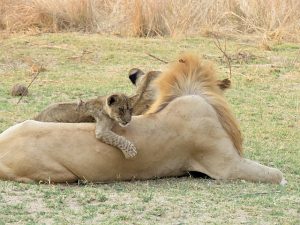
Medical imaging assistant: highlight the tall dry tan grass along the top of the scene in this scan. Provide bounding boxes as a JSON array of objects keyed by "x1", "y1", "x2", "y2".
[{"x1": 0, "y1": 0, "x2": 300, "y2": 41}]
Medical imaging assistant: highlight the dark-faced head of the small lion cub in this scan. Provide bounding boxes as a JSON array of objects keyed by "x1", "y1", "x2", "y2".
[{"x1": 104, "y1": 94, "x2": 132, "y2": 126}]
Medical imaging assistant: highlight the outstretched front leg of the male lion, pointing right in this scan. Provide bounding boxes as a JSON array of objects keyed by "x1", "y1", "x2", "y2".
[{"x1": 191, "y1": 138, "x2": 286, "y2": 185}]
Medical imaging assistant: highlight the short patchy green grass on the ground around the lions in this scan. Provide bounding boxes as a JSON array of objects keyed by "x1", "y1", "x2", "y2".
[{"x1": 0, "y1": 33, "x2": 300, "y2": 225}]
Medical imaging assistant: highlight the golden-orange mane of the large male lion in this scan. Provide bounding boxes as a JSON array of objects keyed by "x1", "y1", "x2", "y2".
[{"x1": 147, "y1": 54, "x2": 243, "y2": 154}]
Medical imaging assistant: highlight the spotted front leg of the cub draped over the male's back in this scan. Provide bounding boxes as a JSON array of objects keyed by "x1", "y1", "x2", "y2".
[{"x1": 95, "y1": 118, "x2": 137, "y2": 159}]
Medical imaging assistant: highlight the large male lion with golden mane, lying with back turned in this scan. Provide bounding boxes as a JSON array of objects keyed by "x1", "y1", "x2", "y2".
[{"x1": 0, "y1": 54, "x2": 285, "y2": 184}]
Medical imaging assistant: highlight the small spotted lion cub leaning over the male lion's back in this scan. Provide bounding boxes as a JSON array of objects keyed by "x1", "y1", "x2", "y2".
[{"x1": 77, "y1": 94, "x2": 137, "y2": 159}]
